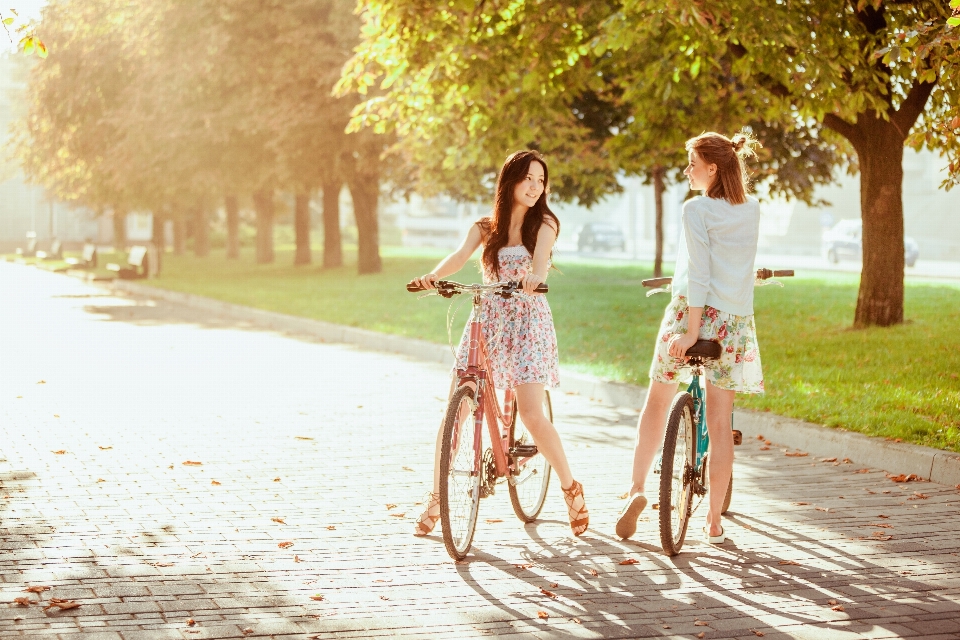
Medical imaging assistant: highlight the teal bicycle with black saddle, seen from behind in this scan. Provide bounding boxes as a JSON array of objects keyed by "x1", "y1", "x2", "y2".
[{"x1": 643, "y1": 269, "x2": 793, "y2": 556}]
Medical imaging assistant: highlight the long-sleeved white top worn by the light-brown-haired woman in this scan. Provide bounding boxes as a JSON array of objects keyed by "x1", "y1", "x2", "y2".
[{"x1": 671, "y1": 196, "x2": 760, "y2": 316}]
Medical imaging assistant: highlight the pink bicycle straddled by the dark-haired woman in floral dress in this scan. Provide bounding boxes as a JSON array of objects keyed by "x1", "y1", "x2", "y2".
[{"x1": 407, "y1": 280, "x2": 553, "y2": 560}]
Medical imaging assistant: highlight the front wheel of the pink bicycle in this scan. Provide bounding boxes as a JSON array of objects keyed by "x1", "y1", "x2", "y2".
[{"x1": 440, "y1": 386, "x2": 481, "y2": 560}]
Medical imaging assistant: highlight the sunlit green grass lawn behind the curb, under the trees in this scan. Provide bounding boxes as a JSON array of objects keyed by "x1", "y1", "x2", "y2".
[{"x1": 16, "y1": 247, "x2": 960, "y2": 451}]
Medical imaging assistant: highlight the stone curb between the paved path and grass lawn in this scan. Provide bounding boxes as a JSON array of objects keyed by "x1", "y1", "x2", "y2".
[{"x1": 107, "y1": 280, "x2": 960, "y2": 485}]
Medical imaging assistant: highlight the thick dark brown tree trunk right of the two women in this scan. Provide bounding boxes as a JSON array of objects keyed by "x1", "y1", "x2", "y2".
[{"x1": 853, "y1": 114, "x2": 905, "y2": 328}]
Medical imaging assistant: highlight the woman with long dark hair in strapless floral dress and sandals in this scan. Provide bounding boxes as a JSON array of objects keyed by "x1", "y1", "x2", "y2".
[{"x1": 415, "y1": 151, "x2": 589, "y2": 536}]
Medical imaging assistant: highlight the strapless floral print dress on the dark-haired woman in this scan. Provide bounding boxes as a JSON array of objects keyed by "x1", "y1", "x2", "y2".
[{"x1": 456, "y1": 245, "x2": 560, "y2": 389}]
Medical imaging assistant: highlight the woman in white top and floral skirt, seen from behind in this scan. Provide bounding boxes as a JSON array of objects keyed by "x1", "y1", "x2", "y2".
[{"x1": 616, "y1": 132, "x2": 763, "y2": 544}]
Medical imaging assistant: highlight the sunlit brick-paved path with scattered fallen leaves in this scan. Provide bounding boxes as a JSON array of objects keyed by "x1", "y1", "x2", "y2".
[{"x1": 0, "y1": 263, "x2": 960, "y2": 640}]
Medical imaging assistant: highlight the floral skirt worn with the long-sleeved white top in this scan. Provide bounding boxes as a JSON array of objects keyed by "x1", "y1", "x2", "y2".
[{"x1": 650, "y1": 296, "x2": 763, "y2": 393}]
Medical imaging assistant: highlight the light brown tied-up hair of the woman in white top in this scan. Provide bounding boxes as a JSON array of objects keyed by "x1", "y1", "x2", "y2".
[{"x1": 686, "y1": 131, "x2": 760, "y2": 204}]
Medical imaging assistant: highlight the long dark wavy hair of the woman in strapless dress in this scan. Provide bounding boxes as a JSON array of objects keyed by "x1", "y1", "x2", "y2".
[{"x1": 479, "y1": 151, "x2": 560, "y2": 279}]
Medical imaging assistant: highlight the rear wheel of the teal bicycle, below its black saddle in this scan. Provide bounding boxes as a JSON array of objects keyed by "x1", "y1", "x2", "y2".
[{"x1": 660, "y1": 392, "x2": 696, "y2": 556}]
